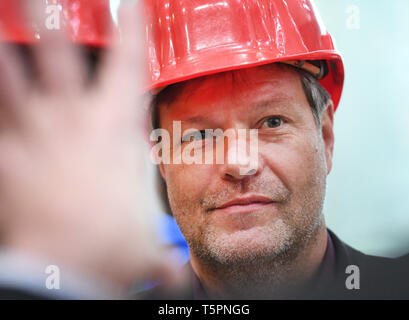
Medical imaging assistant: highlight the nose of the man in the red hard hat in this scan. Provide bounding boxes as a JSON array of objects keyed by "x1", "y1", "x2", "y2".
[{"x1": 215, "y1": 129, "x2": 261, "y2": 181}]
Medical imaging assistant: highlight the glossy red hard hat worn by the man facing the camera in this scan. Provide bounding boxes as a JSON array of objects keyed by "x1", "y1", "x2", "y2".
[{"x1": 145, "y1": 0, "x2": 344, "y2": 109}]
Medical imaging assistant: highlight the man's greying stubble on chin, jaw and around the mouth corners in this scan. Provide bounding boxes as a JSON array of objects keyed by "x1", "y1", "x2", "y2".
[{"x1": 182, "y1": 175, "x2": 325, "y2": 268}]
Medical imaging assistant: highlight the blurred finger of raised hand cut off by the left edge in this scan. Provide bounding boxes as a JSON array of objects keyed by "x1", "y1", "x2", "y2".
[{"x1": 0, "y1": 41, "x2": 28, "y2": 122}]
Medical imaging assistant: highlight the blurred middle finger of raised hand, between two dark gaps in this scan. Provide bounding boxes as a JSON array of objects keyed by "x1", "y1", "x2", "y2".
[{"x1": 25, "y1": 1, "x2": 86, "y2": 94}]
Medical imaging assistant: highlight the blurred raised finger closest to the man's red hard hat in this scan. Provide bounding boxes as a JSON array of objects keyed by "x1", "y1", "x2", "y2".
[{"x1": 99, "y1": 3, "x2": 145, "y2": 107}]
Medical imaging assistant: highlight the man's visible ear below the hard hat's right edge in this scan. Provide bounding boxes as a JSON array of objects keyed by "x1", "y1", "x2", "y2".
[{"x1": 321, "y1": 101, "x2": 334, "y2": 174}]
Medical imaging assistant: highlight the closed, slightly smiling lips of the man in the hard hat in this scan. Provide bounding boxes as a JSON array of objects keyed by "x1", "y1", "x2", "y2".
[{"x1": 212, "y1": 195, "x2": 275, "y2": 214}]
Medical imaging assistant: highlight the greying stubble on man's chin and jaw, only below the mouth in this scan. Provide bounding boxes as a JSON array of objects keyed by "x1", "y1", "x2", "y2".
[{"x1": 186, "y1": 202, "x2": 323, "y2": 268}]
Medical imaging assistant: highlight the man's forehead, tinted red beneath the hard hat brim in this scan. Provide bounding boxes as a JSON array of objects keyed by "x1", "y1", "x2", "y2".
[{"x1": 160, "y1": 63, "x2": 305, "y2": 119}]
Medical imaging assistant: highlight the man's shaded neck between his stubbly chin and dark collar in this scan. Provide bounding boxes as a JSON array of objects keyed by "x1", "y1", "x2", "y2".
[{"x1": 191, "y1": 221, "x2": 327, "y2": 299}]
